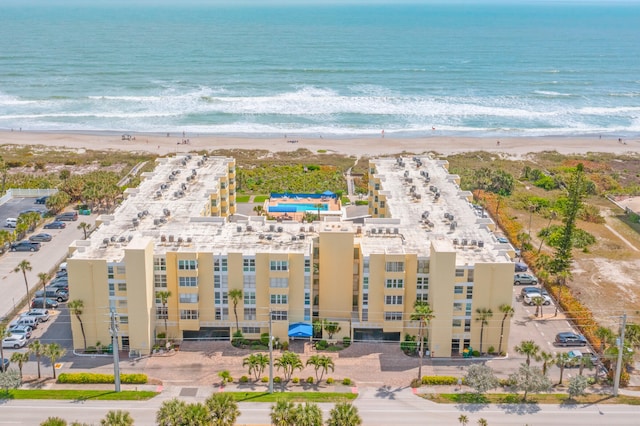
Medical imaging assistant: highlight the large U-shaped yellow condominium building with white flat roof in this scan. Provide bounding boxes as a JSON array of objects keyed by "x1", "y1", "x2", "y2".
[{"x1": 68, "y1": 155, "x2": 514, "y2": 357}]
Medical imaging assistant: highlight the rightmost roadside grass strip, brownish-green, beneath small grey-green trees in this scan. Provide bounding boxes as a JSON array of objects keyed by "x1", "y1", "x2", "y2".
[{"x1": 420, "y1": 393, "x2": 640, "y2": 405}]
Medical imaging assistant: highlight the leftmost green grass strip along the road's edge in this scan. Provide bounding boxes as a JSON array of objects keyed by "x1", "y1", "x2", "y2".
[{"x1": 0, "y1": 389, "x2": 158, "y2": 401}]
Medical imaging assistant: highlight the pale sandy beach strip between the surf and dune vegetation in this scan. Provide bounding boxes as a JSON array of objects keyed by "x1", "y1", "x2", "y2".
[{"x1": 0, "y1": 131, "x2": 640, "y2": 157}]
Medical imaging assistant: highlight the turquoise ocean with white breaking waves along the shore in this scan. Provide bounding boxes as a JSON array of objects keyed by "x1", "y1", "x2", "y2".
[{"x1": 0, "y1": 1, "x2": 640, "y2": 138}]
